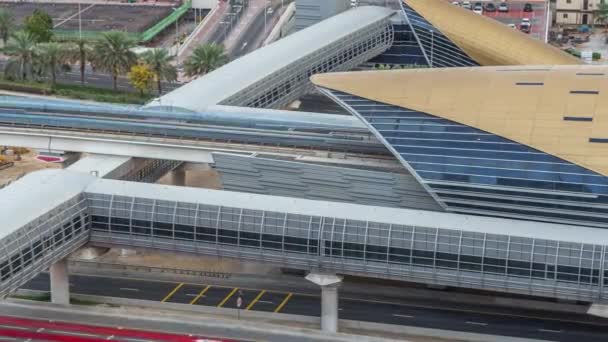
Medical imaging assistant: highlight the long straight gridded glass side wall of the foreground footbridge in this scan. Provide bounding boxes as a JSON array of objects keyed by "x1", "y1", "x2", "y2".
[{"x1": 86, "y1": 193, "x2": 608, "y2": 300}]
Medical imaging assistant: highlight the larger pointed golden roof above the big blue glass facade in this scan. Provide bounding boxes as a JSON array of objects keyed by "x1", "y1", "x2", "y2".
[{"x1": 311, "y1": 65, "x2": 608, "y2": 176}]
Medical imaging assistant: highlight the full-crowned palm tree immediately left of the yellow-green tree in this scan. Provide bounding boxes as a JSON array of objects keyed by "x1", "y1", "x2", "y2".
[{"x1": 92, "y1": 31, "x2": 137, "y2": 90}]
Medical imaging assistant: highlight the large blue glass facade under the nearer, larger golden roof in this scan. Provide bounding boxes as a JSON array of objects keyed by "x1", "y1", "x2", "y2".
[{"x1": 332, "y1": 92, "x2": 608, "y2": 228}]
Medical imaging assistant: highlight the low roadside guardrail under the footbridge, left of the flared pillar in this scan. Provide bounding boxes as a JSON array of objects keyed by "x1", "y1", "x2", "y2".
[{"x1": 69, "y1": 260, "x2": 232, "y2": 279}]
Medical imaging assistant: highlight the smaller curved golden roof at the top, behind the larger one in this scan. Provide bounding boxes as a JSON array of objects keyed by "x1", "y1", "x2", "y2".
[{"x1": 403, "y1": 0, "x2": 582, "y2": 65}]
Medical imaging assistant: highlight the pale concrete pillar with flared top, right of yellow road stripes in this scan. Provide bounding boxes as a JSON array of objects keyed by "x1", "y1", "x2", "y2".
[{"x1": 306, "y1": 273, "x2": 342, "y2": 333}]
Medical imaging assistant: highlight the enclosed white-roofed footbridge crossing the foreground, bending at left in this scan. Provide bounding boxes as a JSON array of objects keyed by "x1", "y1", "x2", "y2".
[{"x1": 0, "y1": 170, "x2": 608, "y2": 301}]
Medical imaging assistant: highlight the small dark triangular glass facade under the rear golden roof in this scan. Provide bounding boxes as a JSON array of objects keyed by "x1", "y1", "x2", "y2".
[{"x1": 370, "y1": 3, "x2": 479, "y2": 68}]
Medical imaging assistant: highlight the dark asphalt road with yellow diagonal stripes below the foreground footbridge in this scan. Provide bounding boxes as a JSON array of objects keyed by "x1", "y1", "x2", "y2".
[{"x1": 24, "y1": 274, "x2": 608, "y2": 342}]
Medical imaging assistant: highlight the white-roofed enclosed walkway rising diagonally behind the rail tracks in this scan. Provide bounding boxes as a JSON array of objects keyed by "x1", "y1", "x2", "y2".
[{"x1": 147, "y1": 6, "x2": 395, "y2": 111}]
